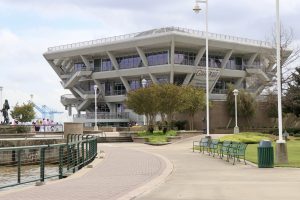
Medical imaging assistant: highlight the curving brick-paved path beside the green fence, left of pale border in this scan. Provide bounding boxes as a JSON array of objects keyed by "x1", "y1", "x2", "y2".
[{"x1": 0, "y1": 145, "x2": 166, "y2": 200}]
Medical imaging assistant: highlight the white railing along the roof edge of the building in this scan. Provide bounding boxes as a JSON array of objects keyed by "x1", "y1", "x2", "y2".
[{"x1": 48, "y1": 26, "x2": 272, "y2": 52}]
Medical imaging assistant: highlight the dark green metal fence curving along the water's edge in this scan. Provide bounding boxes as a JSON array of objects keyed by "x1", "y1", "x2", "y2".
[{"x1": 0, "y1": 134, "x2": 97, "y2": 189}]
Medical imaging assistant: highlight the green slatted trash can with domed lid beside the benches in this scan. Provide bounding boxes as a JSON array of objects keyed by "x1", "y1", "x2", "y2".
[{"x1": 257, "y1": 140, "x2": 274, "y2": 168}]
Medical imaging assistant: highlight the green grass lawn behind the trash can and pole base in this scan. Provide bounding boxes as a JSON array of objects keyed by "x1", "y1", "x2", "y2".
[{"x1": 246, "y1": 139, "x2": 300, "y2": 167}]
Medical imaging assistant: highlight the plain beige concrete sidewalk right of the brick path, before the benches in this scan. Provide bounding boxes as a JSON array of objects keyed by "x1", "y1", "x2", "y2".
[{"x1": 120, "y1": 136, "x2": 300, "y2": 200}]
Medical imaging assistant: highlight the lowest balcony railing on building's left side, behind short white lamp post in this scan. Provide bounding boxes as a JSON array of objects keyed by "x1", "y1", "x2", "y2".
[{"x1": 73, "y1": 112, "x2": 129, "y2": 120}]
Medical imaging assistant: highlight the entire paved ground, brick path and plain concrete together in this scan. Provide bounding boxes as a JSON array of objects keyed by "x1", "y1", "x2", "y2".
[{"x1": 0, "y1": 137, "x2": 300, "y2": 200}]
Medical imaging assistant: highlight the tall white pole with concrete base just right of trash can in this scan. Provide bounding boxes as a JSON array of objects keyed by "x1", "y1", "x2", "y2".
[{"x1": 276, "y1": 0, "x2": 288, "y2": 163}]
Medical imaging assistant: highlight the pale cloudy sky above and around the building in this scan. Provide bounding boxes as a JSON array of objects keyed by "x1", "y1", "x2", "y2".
[{"x1": 0, "y1": 0, "x2": 300, "y2": 121}]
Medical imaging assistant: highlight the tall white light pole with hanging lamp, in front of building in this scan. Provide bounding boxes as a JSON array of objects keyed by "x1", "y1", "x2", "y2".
[{"x1": 193, "y1": 0, "x2": 209, "y2": 136}]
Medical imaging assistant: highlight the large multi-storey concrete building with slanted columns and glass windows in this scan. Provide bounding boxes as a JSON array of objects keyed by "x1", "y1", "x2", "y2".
[{"x1": 44, "y1": 27, "x2": 289, "y2": 126}]
